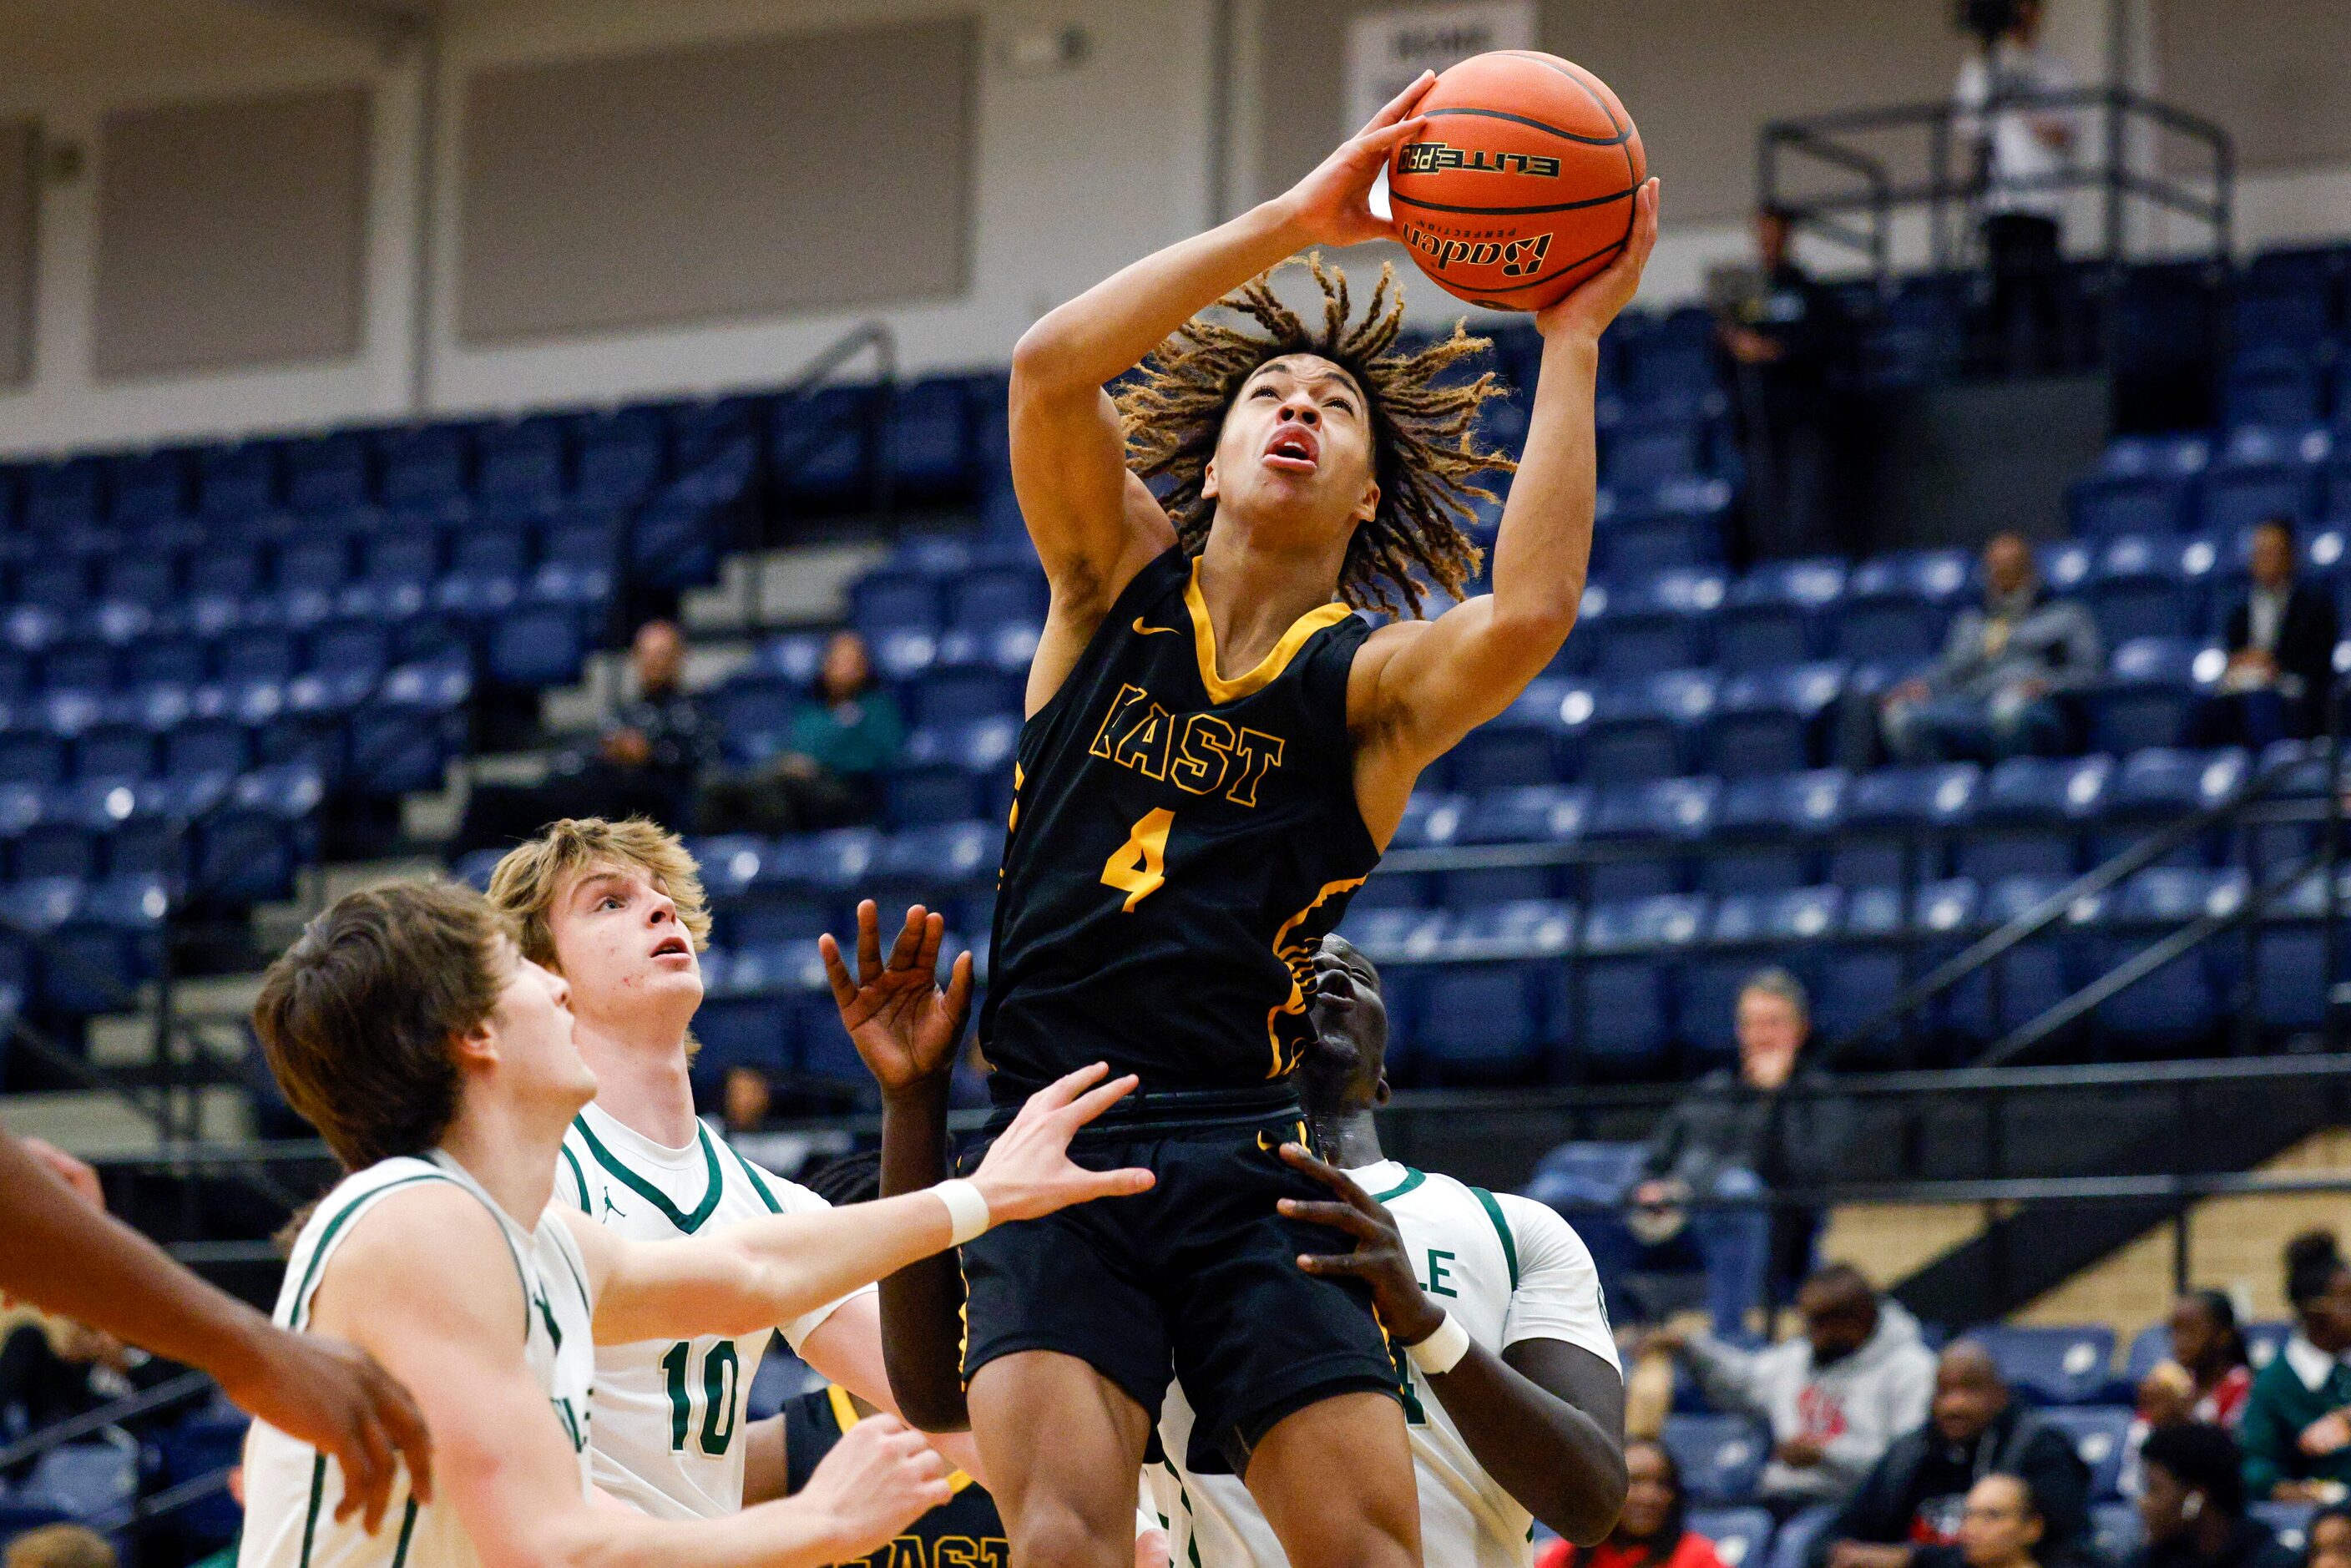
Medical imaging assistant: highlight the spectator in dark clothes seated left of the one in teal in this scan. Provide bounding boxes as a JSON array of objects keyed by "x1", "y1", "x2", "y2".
[{"x1": 452, "y1": 620, "x2": 717, "y2": 858}]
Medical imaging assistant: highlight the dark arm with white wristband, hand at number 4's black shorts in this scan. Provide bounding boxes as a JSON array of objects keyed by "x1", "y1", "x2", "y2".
[{"x1": 1282, "y1": 1142, "x2": 1625, "y2": 1547}]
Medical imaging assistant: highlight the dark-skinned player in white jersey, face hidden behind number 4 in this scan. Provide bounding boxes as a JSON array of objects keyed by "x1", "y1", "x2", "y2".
[{"x1": 1145, "y1": 936, "x2": 1625, "y2": 1568}]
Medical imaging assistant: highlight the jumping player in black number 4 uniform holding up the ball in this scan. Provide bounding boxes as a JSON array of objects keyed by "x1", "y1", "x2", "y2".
[{"x1": 827, "y1": 78, "x2": 1657, "y2": 1568}]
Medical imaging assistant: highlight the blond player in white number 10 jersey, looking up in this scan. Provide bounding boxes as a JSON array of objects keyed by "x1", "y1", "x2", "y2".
[{"x1": 489, "y1": 818, "x2": 978, "y2": 1519}]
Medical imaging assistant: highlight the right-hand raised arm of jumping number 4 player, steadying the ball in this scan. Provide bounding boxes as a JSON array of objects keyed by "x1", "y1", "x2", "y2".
[{"x1": 1347, "y1": 179, "x2": 1657, "y2": 811}]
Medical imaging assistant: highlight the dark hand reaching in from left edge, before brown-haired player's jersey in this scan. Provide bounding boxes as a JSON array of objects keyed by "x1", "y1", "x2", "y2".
[{"x1": 221, "y1": 1328, "x2": 432, "y2": 1535}]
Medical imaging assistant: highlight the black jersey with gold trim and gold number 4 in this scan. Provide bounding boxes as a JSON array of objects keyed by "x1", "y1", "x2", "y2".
[{"x1": 980, "y1": 550, "x2": 1380, "y2": 1103}]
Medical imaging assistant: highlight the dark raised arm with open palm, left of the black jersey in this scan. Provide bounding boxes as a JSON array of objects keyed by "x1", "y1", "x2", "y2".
[{"x1": 816, "y1": 898, "x2": 971, "y2": 1432}]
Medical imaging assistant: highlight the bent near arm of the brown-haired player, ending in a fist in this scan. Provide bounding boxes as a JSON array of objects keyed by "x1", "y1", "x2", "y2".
[{"x1": 313, "y1": 1182, "x2": 948, "y2": 1568}]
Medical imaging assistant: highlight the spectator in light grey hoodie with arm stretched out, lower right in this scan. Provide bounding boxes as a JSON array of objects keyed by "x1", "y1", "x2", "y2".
[{"x1": 1643, "y1": 1262, "x2": 1935, "y2": 1540}]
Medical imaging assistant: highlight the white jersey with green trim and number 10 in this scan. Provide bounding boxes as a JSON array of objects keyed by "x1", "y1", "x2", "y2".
[{"x1": 555, "y1": 1105, "x2": 872, "y2": 1519}]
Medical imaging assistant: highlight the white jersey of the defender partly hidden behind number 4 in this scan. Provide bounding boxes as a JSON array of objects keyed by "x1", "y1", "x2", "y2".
[{"x1": 1143, "y1": 1159, "x2": 1622, "y2": 1568}]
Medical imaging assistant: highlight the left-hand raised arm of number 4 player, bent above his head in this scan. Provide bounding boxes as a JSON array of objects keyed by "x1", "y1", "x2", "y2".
[{"x1": 1011, "y1": 75, "x2": 1432, "y2": 625}]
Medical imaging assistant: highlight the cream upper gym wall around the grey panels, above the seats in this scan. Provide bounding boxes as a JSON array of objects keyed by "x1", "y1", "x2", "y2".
[{"x1": 0, "y1": 0, "x2": 2351, "y2": 453}]
